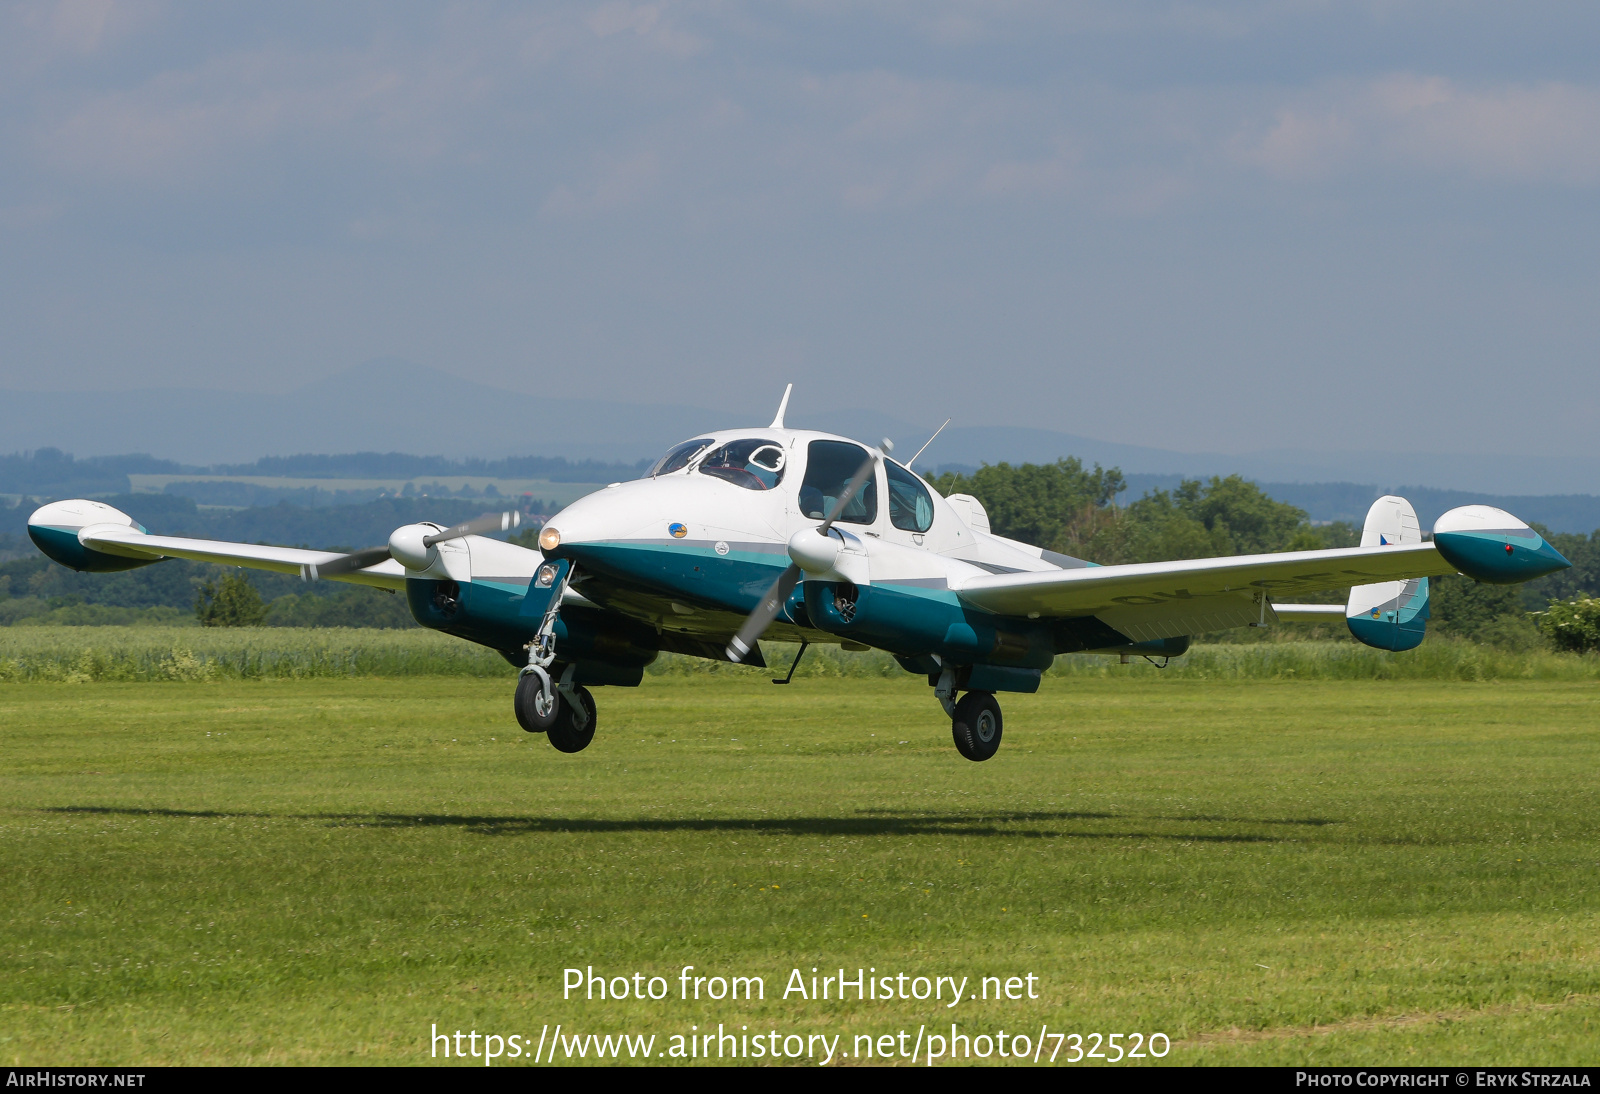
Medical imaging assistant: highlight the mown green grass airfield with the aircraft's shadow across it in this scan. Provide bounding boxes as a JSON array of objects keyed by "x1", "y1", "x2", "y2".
[{"x1": 0, "y1": 670, "x2": 1600, "y2": 1064}]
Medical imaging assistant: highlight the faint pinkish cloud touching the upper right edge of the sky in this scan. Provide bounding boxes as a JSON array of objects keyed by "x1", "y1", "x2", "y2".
[{"x1": 1232, "y1": 74, "x2": 1600, "y2": 187}]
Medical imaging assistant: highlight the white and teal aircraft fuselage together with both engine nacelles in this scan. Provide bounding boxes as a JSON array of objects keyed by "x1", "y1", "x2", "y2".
[{"x1": 252, "y1": 427, "x2": 1187, "y2": 671}]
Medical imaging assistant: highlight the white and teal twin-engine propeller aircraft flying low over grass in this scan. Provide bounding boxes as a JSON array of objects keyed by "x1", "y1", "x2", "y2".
[{"x1": 29, "y1": 385, "x2": 1570, "y2": 760}]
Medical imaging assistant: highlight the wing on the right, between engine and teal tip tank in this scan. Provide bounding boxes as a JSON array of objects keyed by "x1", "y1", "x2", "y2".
[{"x1": 955, "y1": 542, "x2": 1456, "y2": 641}]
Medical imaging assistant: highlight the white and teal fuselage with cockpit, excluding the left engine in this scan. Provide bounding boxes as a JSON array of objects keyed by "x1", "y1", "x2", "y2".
[{"x1": 518, "y1": 429, "x2": 1171, "y2": 672}]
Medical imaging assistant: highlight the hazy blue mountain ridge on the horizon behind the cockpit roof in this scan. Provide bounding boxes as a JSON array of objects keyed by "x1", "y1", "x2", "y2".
[{"x1": 0, "y1": 358, "x2": 1600, "y2": 496}]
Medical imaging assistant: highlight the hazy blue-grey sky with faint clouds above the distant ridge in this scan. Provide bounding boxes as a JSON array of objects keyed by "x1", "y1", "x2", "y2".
[{"x1": 0, "y1": 0, "x2": 1600, "y2": 456}]
